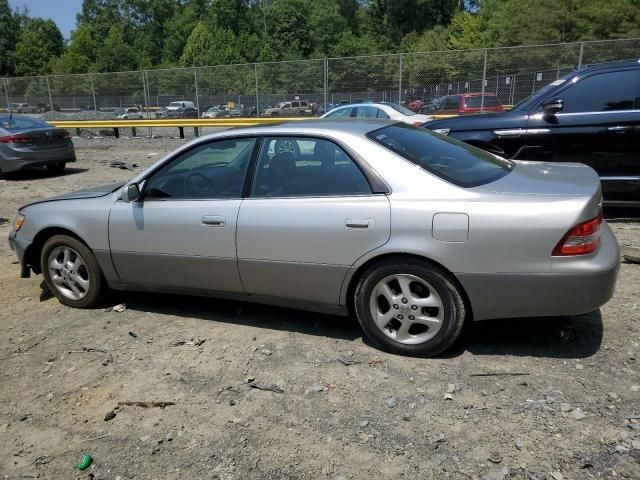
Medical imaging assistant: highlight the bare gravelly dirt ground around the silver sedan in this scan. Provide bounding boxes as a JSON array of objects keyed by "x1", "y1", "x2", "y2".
[{"x1": 0, "y1": 138, "x2": 640, "y2": 480}]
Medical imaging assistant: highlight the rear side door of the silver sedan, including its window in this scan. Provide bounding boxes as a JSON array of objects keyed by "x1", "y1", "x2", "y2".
[{"x1": 237, "y1": 137, "x2": 390, "y2": 305}]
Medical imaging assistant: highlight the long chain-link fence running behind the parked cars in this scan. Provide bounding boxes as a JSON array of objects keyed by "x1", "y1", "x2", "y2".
[{"x1": 0, "y1": 39, "x2": 640, "y2": 120}]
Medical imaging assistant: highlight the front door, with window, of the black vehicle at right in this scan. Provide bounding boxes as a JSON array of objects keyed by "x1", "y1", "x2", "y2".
[{"x1": 527, "y1": 67, "x2": 640, "y2": 200}]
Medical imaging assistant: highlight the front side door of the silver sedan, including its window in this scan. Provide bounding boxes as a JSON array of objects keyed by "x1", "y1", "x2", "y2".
[{"x1": 109, "y1": 138, "x2": 256, "y2": 293}]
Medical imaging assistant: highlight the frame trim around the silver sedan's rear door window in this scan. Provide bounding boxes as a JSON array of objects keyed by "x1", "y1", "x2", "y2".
[{"x1": 249, "y1": 133, "x2": 391, "y2": 199}]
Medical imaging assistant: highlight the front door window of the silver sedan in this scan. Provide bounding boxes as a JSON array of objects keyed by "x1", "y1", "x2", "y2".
[{"x1": 144, "y1": 138, "x2": 256, "y2": 200}]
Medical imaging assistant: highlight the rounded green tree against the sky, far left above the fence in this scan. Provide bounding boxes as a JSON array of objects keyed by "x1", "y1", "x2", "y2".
[{"x1": 15, "y1": 18, "x2": 64, "y2": 76}]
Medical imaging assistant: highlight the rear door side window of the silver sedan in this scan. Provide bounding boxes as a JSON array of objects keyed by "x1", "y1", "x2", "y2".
[{"x1": 251, "y1": 137, "x2": 371, "y2": 197}]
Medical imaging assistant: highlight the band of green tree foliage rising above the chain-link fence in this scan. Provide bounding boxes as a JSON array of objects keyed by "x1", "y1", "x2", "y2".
[{"x1": 0, "y1": 0, "x2": 640, "y2": 76}]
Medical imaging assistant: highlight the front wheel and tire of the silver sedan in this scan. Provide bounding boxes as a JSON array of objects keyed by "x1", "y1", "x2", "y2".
[{"x1": 40, "y1": 235, "x2": 107, "y2": 308}]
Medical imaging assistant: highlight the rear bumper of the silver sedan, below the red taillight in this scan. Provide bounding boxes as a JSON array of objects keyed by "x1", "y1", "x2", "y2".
[{"x1": 457, "y1": 223, "x2": 620, "y2": 320}]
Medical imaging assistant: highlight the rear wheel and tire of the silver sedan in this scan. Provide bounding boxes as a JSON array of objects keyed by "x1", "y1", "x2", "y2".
[{"x1": 354, "y1": 259, "x2": 467, "y2": 357}]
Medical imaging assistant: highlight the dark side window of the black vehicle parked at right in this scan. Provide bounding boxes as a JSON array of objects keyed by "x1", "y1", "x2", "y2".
[{"x1": 557, "y1": 70, "x2": 636, "y2": 113}]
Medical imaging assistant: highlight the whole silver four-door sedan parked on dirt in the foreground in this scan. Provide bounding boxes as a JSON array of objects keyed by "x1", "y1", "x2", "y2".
[{"x1": 9, "y1": 120, "x2": 619, "y2": 356}]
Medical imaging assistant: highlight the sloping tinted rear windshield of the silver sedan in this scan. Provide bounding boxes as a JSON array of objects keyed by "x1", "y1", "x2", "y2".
[{"x1": 367, "y1": 124, "x2": 513, "y2": 188}]
